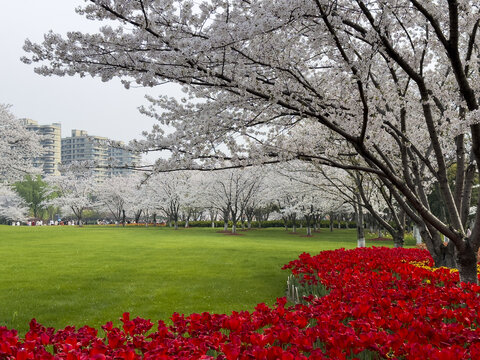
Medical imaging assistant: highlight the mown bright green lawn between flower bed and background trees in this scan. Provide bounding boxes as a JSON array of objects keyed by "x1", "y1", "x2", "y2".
[{"x1": 0, "y1": 226, "x2": 408, "y2": 334}]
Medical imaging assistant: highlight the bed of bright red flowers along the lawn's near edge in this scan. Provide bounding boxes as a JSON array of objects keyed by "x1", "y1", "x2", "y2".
[{"x1": 0, "y1": 248, "x2": 480, "y2": 360}]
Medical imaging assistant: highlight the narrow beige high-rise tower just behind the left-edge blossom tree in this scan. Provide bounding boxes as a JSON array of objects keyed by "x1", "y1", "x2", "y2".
[{"x1": 22, "y1": 119, "x2": 62, "y2": 175}]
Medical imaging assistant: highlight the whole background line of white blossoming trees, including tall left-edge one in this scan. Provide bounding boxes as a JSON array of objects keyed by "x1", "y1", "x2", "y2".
[{"x1": 0, "y1": 107, "x2": 394, "y2": 240}]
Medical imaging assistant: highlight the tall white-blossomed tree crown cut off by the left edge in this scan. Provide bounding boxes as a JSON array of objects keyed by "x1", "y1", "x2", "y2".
[{"x1": 0, "y1": 104, "x2": 44, "y2": 182}]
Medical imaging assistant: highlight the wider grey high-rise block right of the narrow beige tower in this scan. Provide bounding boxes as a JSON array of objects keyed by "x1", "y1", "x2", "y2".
[{"x1": 62, "y1": 130, "x2": 140, "y2": 179}]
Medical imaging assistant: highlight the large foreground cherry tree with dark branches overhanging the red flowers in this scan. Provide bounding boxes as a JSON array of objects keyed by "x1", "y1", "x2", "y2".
[{"x1": 24, "y1": 0, "x2": 480, "y2": 283}]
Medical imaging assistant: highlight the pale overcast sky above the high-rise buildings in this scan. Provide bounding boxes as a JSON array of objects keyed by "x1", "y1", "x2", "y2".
[{"x1": 0, "y1": 0, "x2": 180, "y2": 163}]
